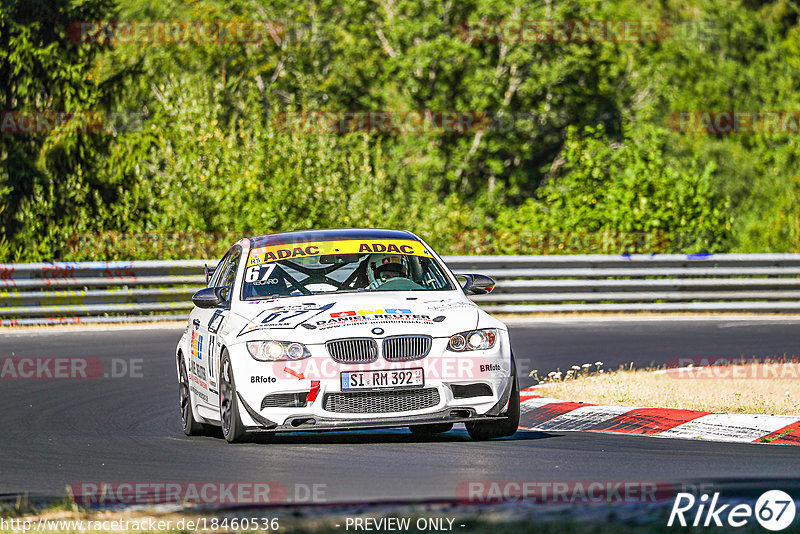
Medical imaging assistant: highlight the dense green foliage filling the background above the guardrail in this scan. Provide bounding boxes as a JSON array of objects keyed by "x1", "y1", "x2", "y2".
[{"x1": 0, "y1": 0, "x2": 800, "y2": 261}]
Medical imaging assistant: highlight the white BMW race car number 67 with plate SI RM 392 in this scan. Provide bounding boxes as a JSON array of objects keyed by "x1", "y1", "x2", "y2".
[{"x1": 175, "y1": 229, "x2": 520, "y2": 442}]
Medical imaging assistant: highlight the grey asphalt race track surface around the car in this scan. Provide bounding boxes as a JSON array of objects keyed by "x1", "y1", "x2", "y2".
[{"x1": 0, "y1": 319, "x2": 800, "y2": 502}]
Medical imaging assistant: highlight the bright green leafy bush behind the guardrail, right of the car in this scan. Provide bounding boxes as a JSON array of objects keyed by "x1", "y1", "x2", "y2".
[{"x1": 498, "y1": 128, "x2": 731, "y2": 253}]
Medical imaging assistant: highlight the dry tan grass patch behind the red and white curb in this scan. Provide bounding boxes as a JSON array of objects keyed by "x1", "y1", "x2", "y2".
[{"x1": 541, "y1": 362, "x2": 800, "y2": 415}]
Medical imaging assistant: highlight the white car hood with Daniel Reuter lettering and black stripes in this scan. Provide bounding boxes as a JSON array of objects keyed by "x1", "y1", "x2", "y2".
[{"x1": 230, "y1": 292, "x2": 479, "y2": 344}]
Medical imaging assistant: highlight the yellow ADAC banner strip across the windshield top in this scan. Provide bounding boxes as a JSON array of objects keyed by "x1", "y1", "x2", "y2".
[{"x1": 247, "y1": 239, "x2": 431, "y2": 266}]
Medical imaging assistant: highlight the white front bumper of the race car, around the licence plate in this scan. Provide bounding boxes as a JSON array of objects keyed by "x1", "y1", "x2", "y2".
[{"x1": 227, "y1": 332, "x2": 512, "y2": 433}]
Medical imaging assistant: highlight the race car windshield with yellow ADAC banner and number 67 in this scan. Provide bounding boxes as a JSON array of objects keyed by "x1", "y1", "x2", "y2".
[{"x1": 242, "y1": 240, "x2": 454, "y2": 300}]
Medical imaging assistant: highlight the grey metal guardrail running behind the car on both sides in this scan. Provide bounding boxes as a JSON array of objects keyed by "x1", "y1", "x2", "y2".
[{"x1": 0, "y1": 254, "x2": 800, "y2": 325}]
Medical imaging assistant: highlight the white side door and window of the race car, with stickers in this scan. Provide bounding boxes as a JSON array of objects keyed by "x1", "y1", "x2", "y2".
[{"x1": 186, "y1": 246, "x2": 242, "y2": 407}]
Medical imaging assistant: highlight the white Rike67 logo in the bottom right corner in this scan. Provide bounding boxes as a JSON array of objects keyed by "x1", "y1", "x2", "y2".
[{"x1": 667, "y1": 490, "x2": 796, "y2": 531}]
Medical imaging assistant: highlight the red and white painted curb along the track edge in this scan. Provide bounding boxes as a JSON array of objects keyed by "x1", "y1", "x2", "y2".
[{"x1": 519, "y1": 388, "x2": 800, "y2": 445}]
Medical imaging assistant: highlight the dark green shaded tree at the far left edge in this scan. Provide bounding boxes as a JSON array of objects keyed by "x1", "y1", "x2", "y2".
[{"x1": 0, "y1": 0, "x2": 134, "y2": 259}]
